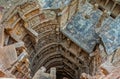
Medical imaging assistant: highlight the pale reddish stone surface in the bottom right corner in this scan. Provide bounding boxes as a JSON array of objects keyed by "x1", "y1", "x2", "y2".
[{"x1": 80, "y1": 63, "x2": 120, "y2": 79}]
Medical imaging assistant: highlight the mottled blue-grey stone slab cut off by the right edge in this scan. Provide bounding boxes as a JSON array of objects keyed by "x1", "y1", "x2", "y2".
[{"x1": 100, "y1": 16, "x2": 120, "y2": 54}]
